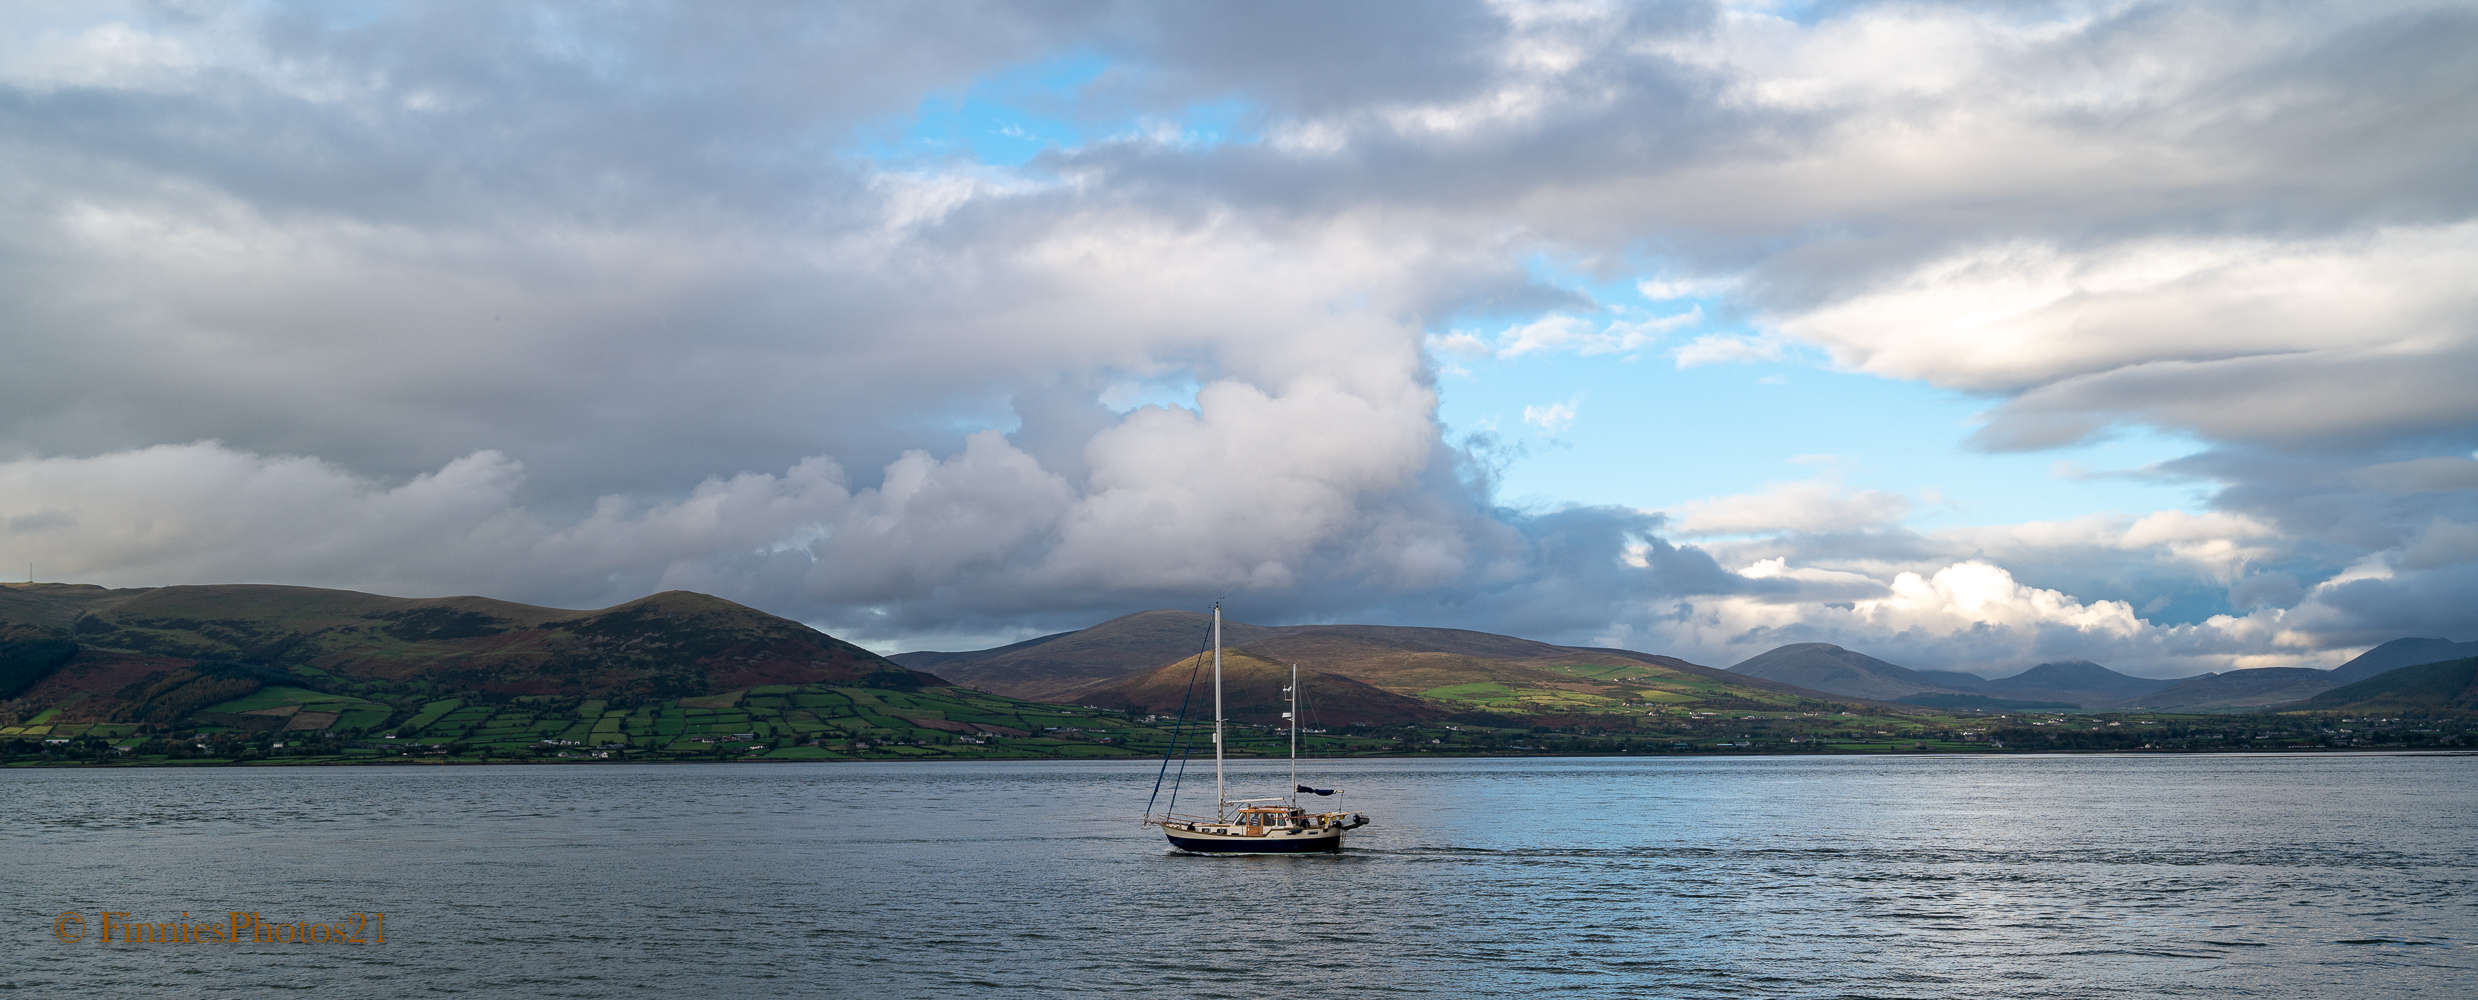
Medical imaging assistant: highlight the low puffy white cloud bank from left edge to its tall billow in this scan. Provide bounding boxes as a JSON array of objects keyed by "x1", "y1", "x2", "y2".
[{"x1": 0, "y1": 379, "x2": 1494, "y2": 623}]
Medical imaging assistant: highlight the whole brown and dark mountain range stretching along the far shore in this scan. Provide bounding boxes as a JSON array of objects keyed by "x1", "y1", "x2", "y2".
[{"x1": 0, "y1": 574, "x2": 2478, "y2": 728}]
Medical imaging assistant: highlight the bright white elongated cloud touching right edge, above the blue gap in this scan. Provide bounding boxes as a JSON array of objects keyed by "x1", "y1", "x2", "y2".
[{"x1": 1777, "y1": 223, "x2": 2478, "y2": 410}]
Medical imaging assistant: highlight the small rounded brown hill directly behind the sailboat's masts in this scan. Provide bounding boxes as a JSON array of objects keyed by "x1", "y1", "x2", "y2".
[{"x1": 1048, "y1": 651, "x2": 1445, "y2": 728}]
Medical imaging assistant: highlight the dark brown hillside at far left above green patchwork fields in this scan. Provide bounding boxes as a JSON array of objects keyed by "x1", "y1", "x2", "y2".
[{"x1": 0, "y1": 584, "x2": 944, "y2": 720}]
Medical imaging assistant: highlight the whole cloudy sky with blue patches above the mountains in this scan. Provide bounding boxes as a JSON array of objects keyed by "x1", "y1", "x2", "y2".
[{"x1": 0, "y1": 0, "x2": 2478, "y2": 676}]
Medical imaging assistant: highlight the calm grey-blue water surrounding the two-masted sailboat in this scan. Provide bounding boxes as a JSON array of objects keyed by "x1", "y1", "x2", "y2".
[{"x1": 0, "y1": 757, "x2": 2478, "y2": 1000}]
